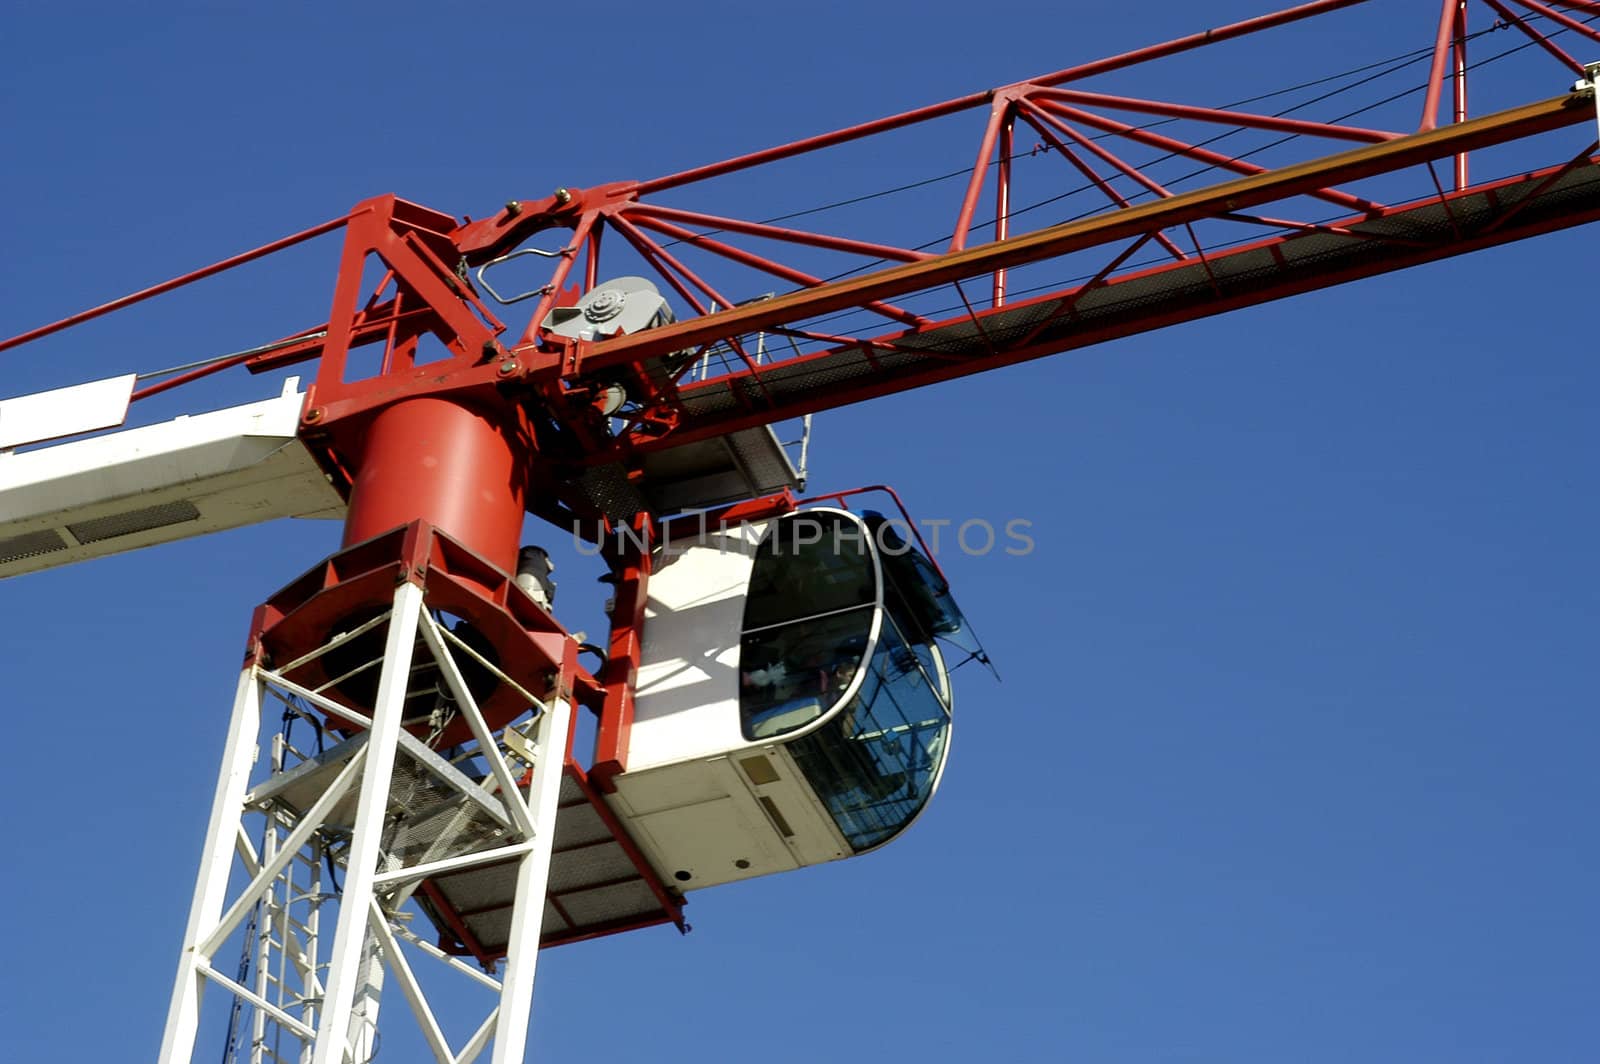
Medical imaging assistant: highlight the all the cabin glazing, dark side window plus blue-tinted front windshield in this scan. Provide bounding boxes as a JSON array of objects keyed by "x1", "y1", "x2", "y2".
[{"x1": 739, "y1": 510, "x2": 963, "y2": 853}]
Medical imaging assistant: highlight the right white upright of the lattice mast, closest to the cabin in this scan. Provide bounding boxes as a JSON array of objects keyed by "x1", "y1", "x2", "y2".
[{"x1": 491, "y1": 698, "x2": 573, "y2": 1064}]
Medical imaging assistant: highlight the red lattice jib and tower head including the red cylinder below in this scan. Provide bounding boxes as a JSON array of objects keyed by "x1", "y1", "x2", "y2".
[{"x1": 0, "y1": 0, "x2": 1600, "y2": 547}]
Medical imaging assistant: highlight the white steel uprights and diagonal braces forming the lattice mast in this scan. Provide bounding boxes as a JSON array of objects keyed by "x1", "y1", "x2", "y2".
[{"x1": 160, "y1": 582, "x2": 573, "y2": 1064}]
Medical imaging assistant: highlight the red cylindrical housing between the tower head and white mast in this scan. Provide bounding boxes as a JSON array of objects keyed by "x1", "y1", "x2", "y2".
[{"x1": 344, "y1": 397, "x2": 531, "y2": 573}]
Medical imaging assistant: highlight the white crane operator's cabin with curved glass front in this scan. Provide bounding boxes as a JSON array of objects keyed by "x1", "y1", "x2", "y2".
[{"x1": 608, "y1": 507, "x2": 965, "y2": 890}]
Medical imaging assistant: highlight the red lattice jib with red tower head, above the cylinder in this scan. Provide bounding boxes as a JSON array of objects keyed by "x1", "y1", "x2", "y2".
[{"x1": 0, "y1": 0, "x2": 1600, "y2": 526}]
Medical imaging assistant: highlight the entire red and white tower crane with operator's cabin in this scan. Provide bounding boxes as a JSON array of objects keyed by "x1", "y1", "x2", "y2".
[{"x1": 0, "y1": 0, "x2": 1600, "y2": 1064}]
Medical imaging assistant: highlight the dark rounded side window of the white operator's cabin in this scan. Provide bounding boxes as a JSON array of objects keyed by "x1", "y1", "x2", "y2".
[{"x1": 739, "y1": 512, "x2": 877, "y2": 739}]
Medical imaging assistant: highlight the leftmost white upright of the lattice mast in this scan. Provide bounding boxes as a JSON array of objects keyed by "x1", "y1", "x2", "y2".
[{"x1": 157, "y1": 667, "x2": 261, "y2": 1064}]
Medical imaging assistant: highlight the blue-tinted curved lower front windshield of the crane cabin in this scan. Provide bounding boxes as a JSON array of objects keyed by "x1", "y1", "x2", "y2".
[{"x1": 789, "y1": 618, "x2": 950, "y2": 853}]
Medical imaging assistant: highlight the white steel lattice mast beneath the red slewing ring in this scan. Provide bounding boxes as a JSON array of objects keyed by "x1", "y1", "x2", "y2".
[{"x1": 160, "y1": 582, "x2": 571, "y2": 1064}]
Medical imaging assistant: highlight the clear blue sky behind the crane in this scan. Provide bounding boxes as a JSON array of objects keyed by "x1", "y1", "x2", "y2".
[{"x1": 0, "y1": 0, "x2": 1600, "y2": 1064}]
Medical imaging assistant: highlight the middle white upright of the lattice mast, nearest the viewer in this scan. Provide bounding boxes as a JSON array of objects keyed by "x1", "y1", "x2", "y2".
[{"x1": 312, "y1": 582, "x2": 422, "y2": 1064}]
